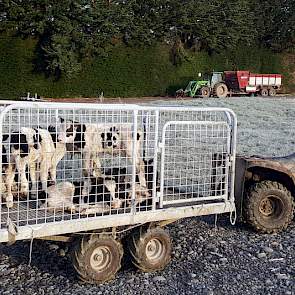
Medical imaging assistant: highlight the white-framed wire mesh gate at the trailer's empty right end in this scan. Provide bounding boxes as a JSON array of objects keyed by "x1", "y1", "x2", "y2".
[{"x1": 161, "y1": 121, "x2": 231, "y2": 205}]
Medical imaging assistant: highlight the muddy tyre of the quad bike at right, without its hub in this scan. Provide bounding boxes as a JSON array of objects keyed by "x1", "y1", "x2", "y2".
[{"x1": 243, "y1": 181, "x2": 294, "y2": 233}]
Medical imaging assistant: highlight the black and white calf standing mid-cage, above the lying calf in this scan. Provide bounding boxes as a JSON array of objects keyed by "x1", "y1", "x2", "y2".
[{"x1": 58, "y1": 120, "x2": 147, "y2": 201}]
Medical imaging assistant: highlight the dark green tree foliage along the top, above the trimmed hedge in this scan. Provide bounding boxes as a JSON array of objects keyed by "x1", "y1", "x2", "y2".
[{"x1": 0, "y1": 0, "x2": 295, "y2": 78}]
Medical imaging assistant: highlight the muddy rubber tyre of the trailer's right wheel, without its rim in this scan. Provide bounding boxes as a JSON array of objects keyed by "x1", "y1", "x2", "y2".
[{"x1": 129, "y1": 227, "x2": 172, "y2": 272}]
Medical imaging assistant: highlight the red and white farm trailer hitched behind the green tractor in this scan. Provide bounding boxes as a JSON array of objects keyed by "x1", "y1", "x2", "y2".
[{"x1": 222, "y1": 71, "x2": 282, "y2": 96}]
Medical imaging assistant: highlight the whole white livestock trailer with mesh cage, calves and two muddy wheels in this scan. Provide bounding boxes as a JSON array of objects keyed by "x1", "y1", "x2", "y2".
[{"x1": 0, "y1": 101, "x2": 237, "y2": 283}]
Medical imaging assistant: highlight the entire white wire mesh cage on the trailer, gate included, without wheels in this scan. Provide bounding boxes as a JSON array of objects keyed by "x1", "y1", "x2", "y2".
[{"x1": 0, "y1": 103, "x2": 235, "y2": 240}]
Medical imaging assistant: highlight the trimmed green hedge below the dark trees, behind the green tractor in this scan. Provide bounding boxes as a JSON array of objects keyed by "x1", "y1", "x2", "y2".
[{"x1": 0, "y1": 36, "x2": 294, "y2": 99}]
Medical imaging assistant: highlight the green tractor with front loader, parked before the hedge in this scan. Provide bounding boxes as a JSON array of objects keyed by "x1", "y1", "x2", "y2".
[{"x1": 176, "y1": 72, "x2": 227, "y2": 98}]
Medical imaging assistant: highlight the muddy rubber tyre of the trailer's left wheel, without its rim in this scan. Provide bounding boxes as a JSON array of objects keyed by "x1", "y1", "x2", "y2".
[{"x1": 72, "y1": 235, "x2": 123, "y2": 284}]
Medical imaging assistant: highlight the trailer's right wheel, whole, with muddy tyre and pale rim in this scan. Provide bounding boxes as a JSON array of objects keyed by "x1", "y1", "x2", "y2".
[{"x1": 129, "y1": 227, "x2": 172, "y2": 272}]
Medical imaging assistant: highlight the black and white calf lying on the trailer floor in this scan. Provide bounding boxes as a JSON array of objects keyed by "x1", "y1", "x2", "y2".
[{"x1": 41, "y1": 161, "x2": 153, "y2": 214}]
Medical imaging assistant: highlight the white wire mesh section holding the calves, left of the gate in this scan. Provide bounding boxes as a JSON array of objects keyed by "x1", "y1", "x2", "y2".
[{"x1": 1, "y1": 105, "x2": 156, "y2": 231}]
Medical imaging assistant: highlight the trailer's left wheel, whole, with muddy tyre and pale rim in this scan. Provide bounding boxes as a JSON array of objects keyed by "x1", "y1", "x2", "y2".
[{"x1": 73, "y1": 235, "x2": 123, "y2": 284}]
